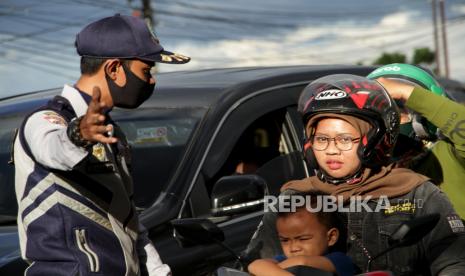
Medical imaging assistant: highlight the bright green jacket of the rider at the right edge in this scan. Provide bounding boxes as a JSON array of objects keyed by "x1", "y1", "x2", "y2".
[{"x1": 406, "y1": 87, "x2": 465, "y2": 218}]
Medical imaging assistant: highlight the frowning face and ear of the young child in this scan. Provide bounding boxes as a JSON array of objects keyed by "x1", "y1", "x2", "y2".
[{"x1": 276, "y1": 208, "x2": 338, "y2": 258}]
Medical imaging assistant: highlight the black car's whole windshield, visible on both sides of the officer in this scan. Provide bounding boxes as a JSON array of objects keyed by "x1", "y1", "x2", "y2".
[{"x1": 0, "y1": 108, "x2": 205, "y2": 224}]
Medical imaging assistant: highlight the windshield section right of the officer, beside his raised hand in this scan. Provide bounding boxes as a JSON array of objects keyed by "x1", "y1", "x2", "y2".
[{"x1": 116, "y1": 108, "x2": 205, "y2": 208}]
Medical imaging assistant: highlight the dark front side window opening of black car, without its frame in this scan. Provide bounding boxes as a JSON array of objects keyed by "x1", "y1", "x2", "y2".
[{"x1": 183, "y1": 107, "x2": 305, "y2": 217}]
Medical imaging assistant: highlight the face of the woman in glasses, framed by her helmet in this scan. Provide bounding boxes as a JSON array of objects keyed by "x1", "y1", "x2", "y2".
[{"x1": 313, "y1": 118, "x2": 360, "y2": 178}]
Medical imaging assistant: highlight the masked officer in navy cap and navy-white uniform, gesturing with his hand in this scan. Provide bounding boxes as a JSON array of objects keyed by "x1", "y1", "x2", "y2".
[{"x1": 14, "y1": 14, "x2": 189, "y2": 275}]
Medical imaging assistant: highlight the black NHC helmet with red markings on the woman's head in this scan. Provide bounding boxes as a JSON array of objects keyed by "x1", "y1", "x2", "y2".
[{"x1": 298, "y1": 74, "x2": 400, "y2": 167}]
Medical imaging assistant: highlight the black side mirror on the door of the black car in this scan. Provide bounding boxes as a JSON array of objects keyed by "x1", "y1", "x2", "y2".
[{"x1": 211, "y1": 174, "x2": 267, "y2": 216}]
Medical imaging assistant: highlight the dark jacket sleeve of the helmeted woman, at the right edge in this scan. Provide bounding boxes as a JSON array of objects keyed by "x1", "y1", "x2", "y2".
[{"x1": 415, "y1": 182, "x2": 465, "y2": 275}]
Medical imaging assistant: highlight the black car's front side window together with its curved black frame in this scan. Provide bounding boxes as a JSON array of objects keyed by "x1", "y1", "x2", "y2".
[{"x1": 180, "y1": 85, "x2": 305, "y2": 217}]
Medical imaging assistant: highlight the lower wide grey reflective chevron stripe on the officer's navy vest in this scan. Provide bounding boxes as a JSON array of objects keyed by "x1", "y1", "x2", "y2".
[{"x1": 23, "y1": 191, "x2": 112, "y2": 231}]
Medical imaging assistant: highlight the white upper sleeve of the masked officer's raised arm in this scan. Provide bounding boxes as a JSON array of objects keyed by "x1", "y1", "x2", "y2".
[{"x1": 24, "y1": 110, "x2": 88, "y2": 171}]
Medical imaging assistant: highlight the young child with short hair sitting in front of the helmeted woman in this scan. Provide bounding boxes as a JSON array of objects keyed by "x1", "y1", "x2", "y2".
[{"x1": 248, "y1": 192, "x2": 354, "y2": 276}]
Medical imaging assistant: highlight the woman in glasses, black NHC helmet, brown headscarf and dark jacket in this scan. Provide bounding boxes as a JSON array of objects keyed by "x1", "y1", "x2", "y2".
[{"x1": 282, "y1": 75, "x2": 465, "y2": 275}]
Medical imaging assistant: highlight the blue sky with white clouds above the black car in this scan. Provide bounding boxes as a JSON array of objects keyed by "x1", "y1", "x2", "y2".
[{"x1": 0, "y1": 0, "x2": 465, "y2": 98}]
